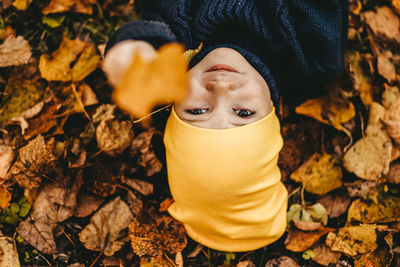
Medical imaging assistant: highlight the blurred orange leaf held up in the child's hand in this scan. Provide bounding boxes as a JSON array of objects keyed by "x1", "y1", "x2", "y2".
[{"x1": 113, "y1": 43, "x2": 189, "y2": 118}]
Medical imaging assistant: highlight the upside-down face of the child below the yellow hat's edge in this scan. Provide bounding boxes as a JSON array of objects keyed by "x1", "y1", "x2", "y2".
[{"x1": 175, "y1": 47, "x2": 272, "y2": 129}]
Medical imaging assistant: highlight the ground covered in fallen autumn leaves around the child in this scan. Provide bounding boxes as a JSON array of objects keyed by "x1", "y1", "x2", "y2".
[{"x1": 0, "y1": 0, "x2": 400, "y2": 267}]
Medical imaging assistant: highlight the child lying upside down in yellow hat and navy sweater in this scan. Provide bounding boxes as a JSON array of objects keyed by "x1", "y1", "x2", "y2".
[{"x1": 104, "y1": 0, "x2": 347, "y2": 252}]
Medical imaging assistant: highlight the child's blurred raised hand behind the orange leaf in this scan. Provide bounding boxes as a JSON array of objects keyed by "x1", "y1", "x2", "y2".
[{"x1": 103, "y1": 40, "x2": 157, "y2": 86}]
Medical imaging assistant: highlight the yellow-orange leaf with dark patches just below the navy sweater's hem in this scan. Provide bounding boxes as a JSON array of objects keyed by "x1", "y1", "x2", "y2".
[{"x1": 296, "y1": 96, "x2": 356, "y2": 131}]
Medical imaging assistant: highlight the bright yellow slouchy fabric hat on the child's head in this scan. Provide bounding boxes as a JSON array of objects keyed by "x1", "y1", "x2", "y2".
[{"x1": 164, "y1": 109, "x2": 287, "y2": 252}]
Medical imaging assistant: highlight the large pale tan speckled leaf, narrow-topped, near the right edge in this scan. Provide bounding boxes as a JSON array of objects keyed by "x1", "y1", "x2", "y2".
[{"x1": 343, "y1": 102, "x2": 392, "y2": 180}]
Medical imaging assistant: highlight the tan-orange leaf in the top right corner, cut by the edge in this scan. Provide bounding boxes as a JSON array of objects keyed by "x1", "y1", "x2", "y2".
[{"x1": 362, "y1": 6, "x2": 400, "y2": 44}]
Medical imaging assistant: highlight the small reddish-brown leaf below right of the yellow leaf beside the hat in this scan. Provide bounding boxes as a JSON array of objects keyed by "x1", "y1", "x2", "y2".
[{"x1": 318, "y1": 189, "x2": 350, "y2": 218}]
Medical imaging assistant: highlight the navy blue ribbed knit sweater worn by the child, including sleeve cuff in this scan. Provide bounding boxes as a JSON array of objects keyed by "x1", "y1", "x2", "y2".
[{"x1": 107, "y1": 0, "x2": 348, "y2": 107}]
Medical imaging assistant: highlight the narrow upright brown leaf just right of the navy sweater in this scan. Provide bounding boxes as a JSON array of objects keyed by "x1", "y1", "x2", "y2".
[{"x1": 346, "y1": 51, "x2": 373, "y2": 107}]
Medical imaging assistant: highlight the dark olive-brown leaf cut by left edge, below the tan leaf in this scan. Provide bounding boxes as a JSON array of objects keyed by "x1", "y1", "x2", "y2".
[{"x1": 0, "y1": 63, "x2": 47, "y2": 128}]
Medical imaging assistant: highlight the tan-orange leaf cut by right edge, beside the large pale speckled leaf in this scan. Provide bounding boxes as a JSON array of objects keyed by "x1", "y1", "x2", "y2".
[{"x1": 383, "y1": 96, "x2": 400, "y2": 145}]
